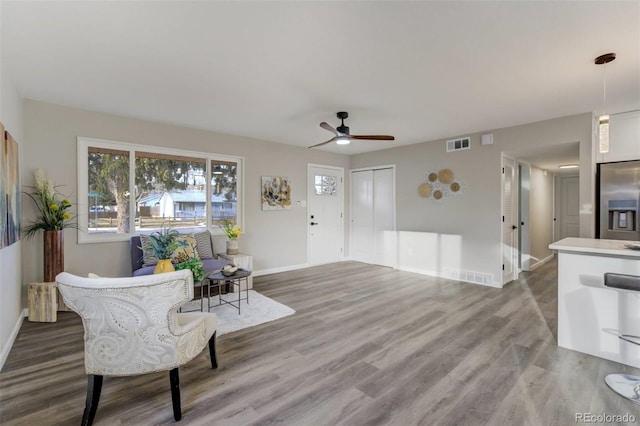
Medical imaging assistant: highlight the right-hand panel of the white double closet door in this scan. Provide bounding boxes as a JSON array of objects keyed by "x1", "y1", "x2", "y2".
[{"x1": 373, "y1": 169, "x2": 396, "y2": 267}]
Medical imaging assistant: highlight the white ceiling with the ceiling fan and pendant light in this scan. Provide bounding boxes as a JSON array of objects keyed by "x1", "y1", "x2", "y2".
[{"x1": 1, "y1": 0, "x2": 640, "y2": 154}]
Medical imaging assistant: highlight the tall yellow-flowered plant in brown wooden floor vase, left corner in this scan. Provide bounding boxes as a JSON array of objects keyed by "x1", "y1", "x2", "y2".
[{"x1": 23, "y1": 169, "x2": 78, "y2": 282}]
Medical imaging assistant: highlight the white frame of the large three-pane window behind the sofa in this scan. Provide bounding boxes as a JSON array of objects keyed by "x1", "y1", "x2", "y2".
[{"x1": 77, "y1": 136, "x2": 245, "y2": 244}]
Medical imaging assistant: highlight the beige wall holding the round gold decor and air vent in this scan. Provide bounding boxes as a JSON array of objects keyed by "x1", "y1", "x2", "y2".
[{"x1": 351, "y1": 113, "x2": 594, "y2": 286}]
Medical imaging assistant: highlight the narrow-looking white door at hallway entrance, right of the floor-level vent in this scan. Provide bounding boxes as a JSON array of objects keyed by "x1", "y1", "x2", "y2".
[{"x1": 502, "y1": 156, "x2": 518, "y2": 284}]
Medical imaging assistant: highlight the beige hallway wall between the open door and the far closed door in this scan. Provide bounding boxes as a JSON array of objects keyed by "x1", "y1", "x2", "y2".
[{"x1": 529, "y1": 166, "x2": 553, "y2": 268}]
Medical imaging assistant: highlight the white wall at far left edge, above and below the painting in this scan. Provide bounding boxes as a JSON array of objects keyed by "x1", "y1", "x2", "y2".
[{"x1": 0, "y1": 2, "x2": 24, "y2": 369}]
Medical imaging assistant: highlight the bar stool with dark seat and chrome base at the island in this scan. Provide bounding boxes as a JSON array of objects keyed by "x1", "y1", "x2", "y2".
[{"x1": 604, "y1": 272, "x2": 640, "y2": 405}]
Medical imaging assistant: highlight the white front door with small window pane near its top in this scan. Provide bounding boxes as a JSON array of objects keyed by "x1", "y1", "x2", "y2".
[{"x1": 307, "y1": 164, "x2": 344, "y2": 265}]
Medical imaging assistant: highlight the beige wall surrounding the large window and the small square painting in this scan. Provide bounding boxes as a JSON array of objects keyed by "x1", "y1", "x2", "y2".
[{"x1": 22, "y1": 100, "x2": 349, "y2": 290}]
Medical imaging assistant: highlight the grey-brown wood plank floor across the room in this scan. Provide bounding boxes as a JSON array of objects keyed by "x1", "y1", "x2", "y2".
[{"x1": 0, "y1": 262, "x2": 640, "y2": 425}]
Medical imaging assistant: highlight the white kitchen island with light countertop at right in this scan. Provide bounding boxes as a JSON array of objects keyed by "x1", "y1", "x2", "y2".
[{"x1": 549, "y1": 238, "x2": 640, "y2": 368}]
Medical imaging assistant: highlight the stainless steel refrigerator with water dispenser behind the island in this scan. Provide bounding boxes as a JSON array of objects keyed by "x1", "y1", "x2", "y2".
[{"x1": 596, "y1": 160, "x2": 640, "y2": 241}]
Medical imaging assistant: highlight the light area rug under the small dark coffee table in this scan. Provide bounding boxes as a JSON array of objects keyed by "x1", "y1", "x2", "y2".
[{"x1": 182, "y1": 290, "x2": 296, "y2": 336}]
